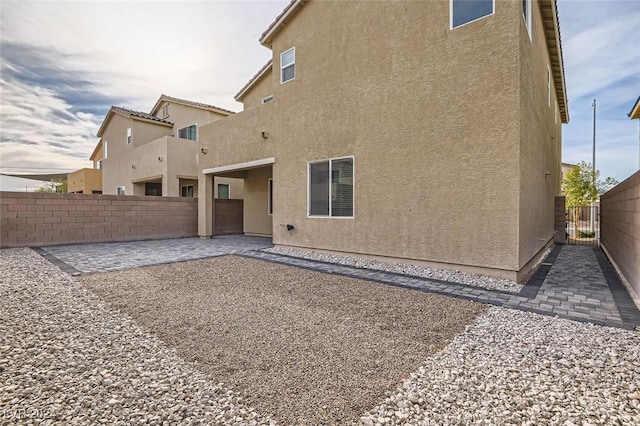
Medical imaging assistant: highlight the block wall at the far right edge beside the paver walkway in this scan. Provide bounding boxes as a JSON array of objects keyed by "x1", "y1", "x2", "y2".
[{"x1": 600, "y1": 171, "x2": 640, "y2": 297}]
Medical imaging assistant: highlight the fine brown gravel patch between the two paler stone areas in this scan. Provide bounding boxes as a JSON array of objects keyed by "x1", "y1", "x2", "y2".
[{"x1": 80, "y1": 256, "x2": 487, "y2": 425}]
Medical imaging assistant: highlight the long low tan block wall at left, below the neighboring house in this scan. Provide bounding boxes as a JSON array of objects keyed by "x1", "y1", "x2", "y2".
[{"x1": 0, "y1": 192, "x2": 198, "y2": 248}]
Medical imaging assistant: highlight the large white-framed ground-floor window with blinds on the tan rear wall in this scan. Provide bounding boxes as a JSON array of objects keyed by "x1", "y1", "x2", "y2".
[{"x1": 307, "y1": 156, "x2": 354, "y2": 218}]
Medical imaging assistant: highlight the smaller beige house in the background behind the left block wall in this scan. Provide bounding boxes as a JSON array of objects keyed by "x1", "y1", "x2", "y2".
[{"x1": 92, "y1": 95, "x2": 243, "y2": 198}]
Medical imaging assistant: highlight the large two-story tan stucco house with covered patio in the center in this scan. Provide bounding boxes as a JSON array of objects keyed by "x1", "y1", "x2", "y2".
[{"x1": 199, "y1": 0, "x2": 569, "y2": 279}]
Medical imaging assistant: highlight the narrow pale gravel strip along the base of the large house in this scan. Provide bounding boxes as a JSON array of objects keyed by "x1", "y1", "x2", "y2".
[{"x1": 262, "y1": 247, "x2": 528, "y2": 293}]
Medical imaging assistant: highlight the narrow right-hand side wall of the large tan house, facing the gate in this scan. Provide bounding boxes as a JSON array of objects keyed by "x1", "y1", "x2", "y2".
[{"x1": 514, "y1": 2, "x2": 562, "y2": 268}]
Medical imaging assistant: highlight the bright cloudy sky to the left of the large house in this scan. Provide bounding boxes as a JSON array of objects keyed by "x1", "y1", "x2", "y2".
[{"x1": 0, "y1": 0, "x2": 288, "y2": 172}]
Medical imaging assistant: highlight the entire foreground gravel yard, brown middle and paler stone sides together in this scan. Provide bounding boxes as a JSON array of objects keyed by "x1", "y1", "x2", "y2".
[{"x1": 0, "y1": 249, "x2": 640, "y2": 426}]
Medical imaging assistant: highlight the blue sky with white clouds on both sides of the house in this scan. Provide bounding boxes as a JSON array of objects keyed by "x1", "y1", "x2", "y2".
[{"x1": 0, "y1": 0, "x2": 640, "y2": 181}]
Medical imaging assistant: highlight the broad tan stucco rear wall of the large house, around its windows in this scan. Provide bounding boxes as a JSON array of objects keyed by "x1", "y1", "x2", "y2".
[{"x1": 199, "y1": 1, "x2": 559, "y2": 274}]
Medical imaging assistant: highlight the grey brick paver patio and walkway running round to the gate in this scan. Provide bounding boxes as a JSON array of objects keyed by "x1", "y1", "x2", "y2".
[{"x1": 38, "y1": 236, "x2": 640, "y2": 329}]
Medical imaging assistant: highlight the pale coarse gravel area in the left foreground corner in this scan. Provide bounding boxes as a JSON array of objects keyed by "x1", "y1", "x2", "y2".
[{"x1": 0, "y1": 249, "x2": 270, "y2": 425}]
